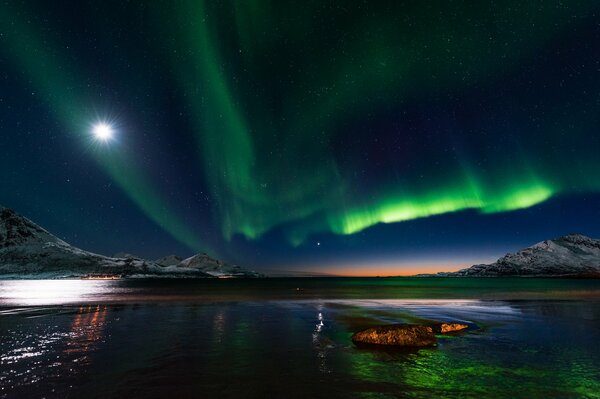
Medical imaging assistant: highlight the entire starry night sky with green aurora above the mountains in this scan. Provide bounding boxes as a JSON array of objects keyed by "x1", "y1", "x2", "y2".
[{"x1": 0, "y1": 0, "x2": 600, "y2": 275}]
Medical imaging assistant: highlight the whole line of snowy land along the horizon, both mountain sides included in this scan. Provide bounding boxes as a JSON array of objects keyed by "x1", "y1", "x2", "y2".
[{"x1": 0, "y1": 207, "x2": 600, "y2": 279}]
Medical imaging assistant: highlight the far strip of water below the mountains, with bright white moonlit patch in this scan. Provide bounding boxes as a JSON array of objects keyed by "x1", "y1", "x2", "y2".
[{"x1": 0, "y1": 277, "x2": 600, "y2": 306}]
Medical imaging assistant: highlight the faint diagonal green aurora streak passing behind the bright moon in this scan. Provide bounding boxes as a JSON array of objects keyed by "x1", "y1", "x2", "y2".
[{"x1": 0, "y1": 4, "x2": 212, "y2": 252}]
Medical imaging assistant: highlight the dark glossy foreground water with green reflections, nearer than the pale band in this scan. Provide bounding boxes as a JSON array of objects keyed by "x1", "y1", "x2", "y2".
[{"x1": 0, "y1": 292, "x2": 600, "y2": 398}]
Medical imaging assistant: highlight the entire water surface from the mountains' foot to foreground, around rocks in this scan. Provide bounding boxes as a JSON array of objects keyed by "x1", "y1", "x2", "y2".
[{"x1": 0, "y1": 278, "x2": 600, "y2": 398}]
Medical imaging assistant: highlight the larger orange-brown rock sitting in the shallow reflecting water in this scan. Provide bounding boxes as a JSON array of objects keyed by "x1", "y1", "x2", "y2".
[{"x1": 352, "y1": 324, "x2": 437, "y2": 347}]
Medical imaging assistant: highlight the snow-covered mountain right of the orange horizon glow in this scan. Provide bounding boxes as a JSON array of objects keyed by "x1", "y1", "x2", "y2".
[{"x1": 450, "y1": 234, "x2": 600, "y2": 277}]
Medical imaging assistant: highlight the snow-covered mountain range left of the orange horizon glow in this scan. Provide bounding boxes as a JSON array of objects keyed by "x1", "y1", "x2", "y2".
[{"x1": 0, "y1": 207, "x2": 259, "y2": 278}]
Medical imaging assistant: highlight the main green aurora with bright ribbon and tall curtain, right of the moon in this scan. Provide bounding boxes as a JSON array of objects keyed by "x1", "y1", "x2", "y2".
[{"x1": 162, "y1": 1, "x2": 600, "y2": 245}]
